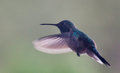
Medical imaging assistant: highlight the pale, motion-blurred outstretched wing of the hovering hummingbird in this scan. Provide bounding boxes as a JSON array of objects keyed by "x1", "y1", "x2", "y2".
[{"x1": 33, "y1": 33, "x2": 72, "y2": 54}]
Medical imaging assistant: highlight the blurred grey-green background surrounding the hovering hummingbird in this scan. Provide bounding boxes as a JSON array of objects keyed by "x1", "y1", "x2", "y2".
[{"x1": 0, "y1": 0, "x2": 120, "y2": 73}]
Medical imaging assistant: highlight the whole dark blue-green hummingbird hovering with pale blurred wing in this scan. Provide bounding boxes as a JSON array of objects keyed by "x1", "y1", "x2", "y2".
[{"x1": 33, "y1": 20, "x2": 110, "y2": 66}]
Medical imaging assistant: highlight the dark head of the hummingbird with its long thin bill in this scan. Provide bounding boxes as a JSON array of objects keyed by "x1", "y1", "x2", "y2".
[{"x1": 41, "y1": 20, "x2": 75, "y2": 33}]
